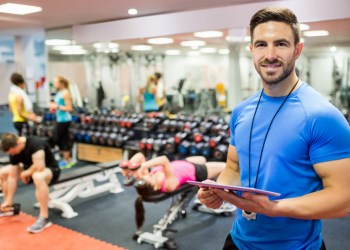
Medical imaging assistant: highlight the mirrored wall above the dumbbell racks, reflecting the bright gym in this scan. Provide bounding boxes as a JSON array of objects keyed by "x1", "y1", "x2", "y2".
[{"x1": 47, "y1": 20, "x2": 350, "y2": 112}]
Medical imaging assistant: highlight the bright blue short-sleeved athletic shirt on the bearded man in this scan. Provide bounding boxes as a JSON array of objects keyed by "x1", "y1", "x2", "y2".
[{"x1": 230, "y1": 83, "x2": 350, "y2": 250}]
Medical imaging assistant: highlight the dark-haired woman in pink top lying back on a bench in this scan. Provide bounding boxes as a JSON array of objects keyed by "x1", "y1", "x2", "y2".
[{"x1": 120, "y1": 153, "x2": 226, "y2": 229}]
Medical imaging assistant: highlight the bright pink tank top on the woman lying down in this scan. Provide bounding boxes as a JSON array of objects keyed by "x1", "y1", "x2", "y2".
[{"x1": 151, "y1": 160, "x2": 196, "y2": 192}]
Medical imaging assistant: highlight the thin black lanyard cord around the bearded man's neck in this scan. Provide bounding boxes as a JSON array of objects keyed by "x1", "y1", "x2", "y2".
[{"x1": 248, "y1": 79, "x2": 299, "y2": 188}]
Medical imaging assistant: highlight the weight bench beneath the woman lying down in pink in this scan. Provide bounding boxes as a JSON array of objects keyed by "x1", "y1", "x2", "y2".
[{"x1": 133, "y1": 184, "x2": 198, "y2": 249}]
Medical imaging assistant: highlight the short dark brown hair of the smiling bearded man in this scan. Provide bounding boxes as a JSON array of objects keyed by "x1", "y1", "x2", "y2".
[{"x1": 249, "y1": 7, "x2": 300, "y2": 44}]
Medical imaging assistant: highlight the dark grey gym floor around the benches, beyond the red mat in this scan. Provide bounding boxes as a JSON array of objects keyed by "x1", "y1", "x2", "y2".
[{"x1": 0, "y1": 111, "x2": 350, "y2": 250}]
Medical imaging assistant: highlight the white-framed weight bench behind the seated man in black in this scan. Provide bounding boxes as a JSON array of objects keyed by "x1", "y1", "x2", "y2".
[{"x1": 35, "y1": 161, "x2": 124, "y2": 219}]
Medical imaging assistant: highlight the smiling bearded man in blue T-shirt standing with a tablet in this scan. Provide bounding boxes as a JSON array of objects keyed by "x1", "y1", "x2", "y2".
[{"x1": 197, "y1": 8, "x2": 350, "y2": 250}]
